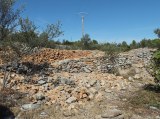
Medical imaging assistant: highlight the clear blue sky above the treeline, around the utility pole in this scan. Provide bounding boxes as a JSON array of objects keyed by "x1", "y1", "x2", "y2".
[{"x1": 16, "y1": 0, "x2": 160, "y2": 43}]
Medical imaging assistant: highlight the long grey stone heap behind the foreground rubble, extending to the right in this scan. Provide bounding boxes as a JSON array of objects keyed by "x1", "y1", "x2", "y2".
[{"x1": 51, "y1": 48, "x2": 153, "y2": 73}]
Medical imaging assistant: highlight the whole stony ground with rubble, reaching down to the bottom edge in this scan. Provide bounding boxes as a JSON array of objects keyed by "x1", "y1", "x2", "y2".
[{"x1": 0, "y1": 48, "x2": 160, "y2": 119}]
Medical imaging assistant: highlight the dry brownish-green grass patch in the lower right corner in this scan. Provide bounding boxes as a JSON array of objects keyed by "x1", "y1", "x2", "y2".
[{"x1": 120, "y1": 89, "x2": 160, "y2": 117}]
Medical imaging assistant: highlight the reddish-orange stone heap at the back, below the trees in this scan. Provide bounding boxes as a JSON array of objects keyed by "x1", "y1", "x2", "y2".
[{"x1": 23, "y1": 48, "x2": 91, "y2": 63}]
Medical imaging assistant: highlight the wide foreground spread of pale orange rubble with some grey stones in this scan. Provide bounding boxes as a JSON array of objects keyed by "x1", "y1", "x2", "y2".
[{"x1": 0, "y1": 73, "x2": 128, "y2": 109}]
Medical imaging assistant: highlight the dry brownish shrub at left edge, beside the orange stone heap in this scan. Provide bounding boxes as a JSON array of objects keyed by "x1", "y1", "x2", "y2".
[{"x1": 0, "y1": 40, "x2": 33, "y2": 88}]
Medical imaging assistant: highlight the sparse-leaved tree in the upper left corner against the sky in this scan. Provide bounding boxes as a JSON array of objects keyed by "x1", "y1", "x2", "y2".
[{"x1": 0, "y1": 0, "x2": 22, "y2": 41}]
